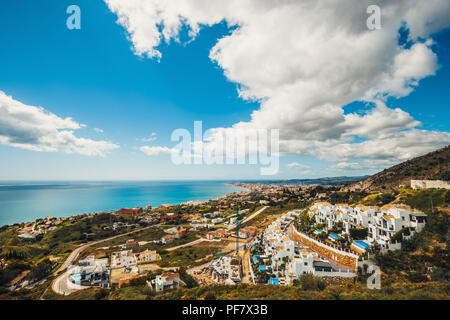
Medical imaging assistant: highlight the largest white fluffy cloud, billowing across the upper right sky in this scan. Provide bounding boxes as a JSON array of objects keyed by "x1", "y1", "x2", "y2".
[{"x1": 105, "y1": 0, "x2": 450, "y2": 171}]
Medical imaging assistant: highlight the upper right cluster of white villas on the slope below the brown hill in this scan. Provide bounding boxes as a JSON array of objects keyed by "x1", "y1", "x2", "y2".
[{"x1": 310, "y1": 202, "x2": 426, "y2": 252}]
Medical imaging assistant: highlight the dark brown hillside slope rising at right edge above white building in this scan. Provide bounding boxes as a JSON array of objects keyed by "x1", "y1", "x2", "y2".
[{"x1": 341, "y1": 145, "x2": 450, "y2": 191}]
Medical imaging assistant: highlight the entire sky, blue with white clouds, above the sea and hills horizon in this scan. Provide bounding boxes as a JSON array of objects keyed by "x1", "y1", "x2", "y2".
[{"x1": 0, "y1": 0, "x2": 450, "y2": 181}]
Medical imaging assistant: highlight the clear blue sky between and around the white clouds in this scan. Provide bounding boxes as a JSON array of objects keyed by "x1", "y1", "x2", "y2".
[{"x1": 0, "y1": 0, "x2": 450, "y2": 180}]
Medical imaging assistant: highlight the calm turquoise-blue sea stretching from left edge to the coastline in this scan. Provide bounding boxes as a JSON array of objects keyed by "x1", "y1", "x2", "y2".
[{"x1": 0, "y1": 181, "x2": 243, "y2": 226}]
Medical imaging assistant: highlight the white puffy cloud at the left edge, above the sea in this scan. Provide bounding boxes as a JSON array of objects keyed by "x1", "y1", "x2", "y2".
[{"x1": 0, "y1": 91, "x2": 119, "y2": 157}]
